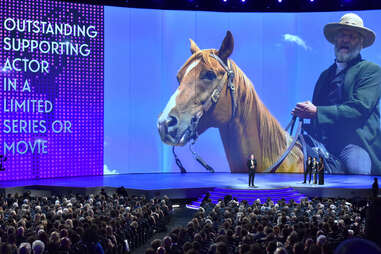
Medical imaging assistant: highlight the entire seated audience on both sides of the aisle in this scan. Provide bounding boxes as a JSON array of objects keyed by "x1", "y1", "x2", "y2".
[{"x1": 0, "y1": 188, "x2": 378, "y2": 254}]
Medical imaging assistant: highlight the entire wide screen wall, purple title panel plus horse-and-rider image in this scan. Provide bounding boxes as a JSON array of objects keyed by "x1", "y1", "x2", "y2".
[{"x1": 0, "y1": 0, "x2": 381, "y2": 180}]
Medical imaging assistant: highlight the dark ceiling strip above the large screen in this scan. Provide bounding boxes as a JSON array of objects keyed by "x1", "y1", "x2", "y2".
[{"x1": 55, "y1": 0, "x2": 381, "y2": 12}]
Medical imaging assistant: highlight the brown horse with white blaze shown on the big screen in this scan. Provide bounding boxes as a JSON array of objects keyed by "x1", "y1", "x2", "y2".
[{"x1": 158, "y1": 31, "x2": 303, "y2": 172}]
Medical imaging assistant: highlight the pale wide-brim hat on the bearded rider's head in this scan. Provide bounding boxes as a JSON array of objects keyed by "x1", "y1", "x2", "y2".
[{"x1": 324, "y1": 13, "x2": 376, "y2": 48}]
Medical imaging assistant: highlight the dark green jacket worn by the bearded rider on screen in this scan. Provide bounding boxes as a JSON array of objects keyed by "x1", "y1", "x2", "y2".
[{"x1": 310, "y1": 56, "x2": 381, "y2": 175}]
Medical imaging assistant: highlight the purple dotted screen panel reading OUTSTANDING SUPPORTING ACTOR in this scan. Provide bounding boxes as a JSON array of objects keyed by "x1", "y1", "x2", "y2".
[{"x1": 0, "y1": 0, "x2": 104, "y2": 180}]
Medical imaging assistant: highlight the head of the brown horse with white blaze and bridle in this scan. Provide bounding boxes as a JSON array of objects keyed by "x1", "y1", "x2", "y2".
[{"x1": 157, "y1": 31, "x2": 234, "y2": 146}]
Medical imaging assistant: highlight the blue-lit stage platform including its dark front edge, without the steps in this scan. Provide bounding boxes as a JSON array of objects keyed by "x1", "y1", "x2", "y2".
[{"x1": 0, "y1": 172, "x2": 374, "y2": 199}]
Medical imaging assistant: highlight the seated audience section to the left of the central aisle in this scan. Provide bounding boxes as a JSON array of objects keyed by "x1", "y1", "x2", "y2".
[{"x1": 0, "y1": 190, "x2": 172, "y2": 254}]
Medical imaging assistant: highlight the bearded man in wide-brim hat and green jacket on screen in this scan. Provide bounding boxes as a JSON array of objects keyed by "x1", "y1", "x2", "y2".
[{"x1": 292, "y1": 13, "x2": 381, "y2": 175}]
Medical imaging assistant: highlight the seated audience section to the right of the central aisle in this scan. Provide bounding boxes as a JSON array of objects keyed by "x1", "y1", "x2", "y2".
[{"x1": 146, "y1": 196, "x2": 379, "y2": 254}]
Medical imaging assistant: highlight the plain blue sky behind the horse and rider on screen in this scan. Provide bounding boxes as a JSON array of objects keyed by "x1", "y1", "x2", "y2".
[{"x1": 104, "y1": 7, "x2": 381, "y2": 174}]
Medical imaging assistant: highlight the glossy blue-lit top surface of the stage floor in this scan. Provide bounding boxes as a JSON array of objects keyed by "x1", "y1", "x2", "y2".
[{"x1": 0, "y1": 173, "x2": 374, "y2": 190}]
